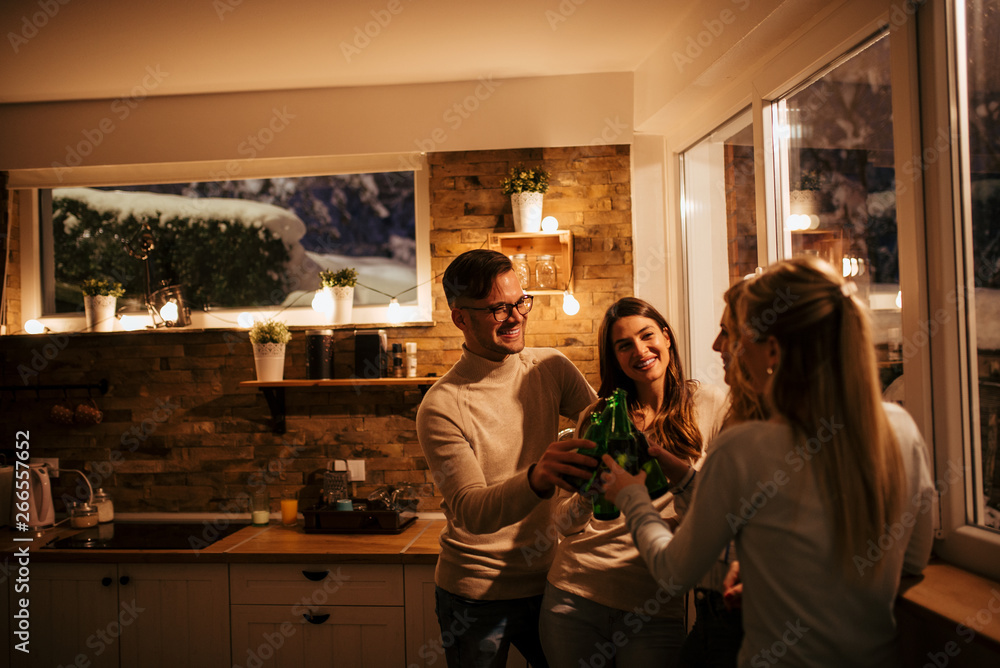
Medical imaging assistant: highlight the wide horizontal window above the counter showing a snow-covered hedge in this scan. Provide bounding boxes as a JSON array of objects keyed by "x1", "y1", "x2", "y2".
[{"x1": 13, "y1": 158, "x2": 432, "y2": 331}]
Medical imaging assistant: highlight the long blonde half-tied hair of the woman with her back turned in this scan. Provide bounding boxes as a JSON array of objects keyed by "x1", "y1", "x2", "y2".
[{"x1": 739, "y1": 257, "x2": 905, "y2": 571}]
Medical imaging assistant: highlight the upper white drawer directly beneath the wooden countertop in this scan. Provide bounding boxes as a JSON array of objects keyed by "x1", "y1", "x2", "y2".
[{"x1": 229, "y1": 564, "x2": 403, "y2": 607}]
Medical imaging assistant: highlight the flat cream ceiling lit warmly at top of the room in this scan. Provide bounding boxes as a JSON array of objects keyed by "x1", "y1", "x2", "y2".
[{"x1": 0, "y1": 0, "x2": 692, "y2": 103}]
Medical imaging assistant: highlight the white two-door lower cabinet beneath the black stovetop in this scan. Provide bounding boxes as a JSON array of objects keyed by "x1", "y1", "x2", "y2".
[{"x1": 11, "y1": 563, "x2": 229, "y2": 668}]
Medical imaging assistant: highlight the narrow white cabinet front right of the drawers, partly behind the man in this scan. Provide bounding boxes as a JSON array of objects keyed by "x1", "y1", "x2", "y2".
[{"x1": 404, "y1": 565, "x2": 528, "y2": 668}]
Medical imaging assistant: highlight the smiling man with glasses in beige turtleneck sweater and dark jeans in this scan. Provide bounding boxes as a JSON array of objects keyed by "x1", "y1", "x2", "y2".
[{"x1": 417, "y1": 249, "x2": 598, "y2": 668}]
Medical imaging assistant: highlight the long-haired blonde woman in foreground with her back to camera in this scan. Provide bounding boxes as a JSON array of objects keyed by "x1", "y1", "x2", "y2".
[{"x1": 605, "y1": 258, "x2": 933, "y2": 668}]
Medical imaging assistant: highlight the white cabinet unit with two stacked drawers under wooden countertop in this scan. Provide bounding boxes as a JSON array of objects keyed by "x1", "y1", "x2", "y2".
[{"x1": 230, "y1": 563, "x2": 406, "y2": 668}]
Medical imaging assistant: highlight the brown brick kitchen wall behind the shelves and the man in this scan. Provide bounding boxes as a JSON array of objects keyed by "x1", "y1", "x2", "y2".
[{"x1": 0, "y1": 146, "x2": 632, "y2": 512}]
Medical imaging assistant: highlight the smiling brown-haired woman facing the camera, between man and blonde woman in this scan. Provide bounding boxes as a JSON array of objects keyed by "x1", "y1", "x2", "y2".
[{"x1": 541, "y1": 297, "x2": 728, "y2": 668}]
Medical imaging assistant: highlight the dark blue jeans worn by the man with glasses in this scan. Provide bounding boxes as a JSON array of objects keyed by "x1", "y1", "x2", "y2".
[{"x1": 434, "y1": 587, "x2": 548, "y2": 668}]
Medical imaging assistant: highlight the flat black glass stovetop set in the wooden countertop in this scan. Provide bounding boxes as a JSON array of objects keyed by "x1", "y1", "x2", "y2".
[{"x1": 45, "y1": 521, "x2": 250, "y2": 550}]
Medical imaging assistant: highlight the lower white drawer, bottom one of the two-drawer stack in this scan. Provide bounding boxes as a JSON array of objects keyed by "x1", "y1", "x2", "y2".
[{"x1": 232, "y1": 605, "x2": 404, "y2": 668}]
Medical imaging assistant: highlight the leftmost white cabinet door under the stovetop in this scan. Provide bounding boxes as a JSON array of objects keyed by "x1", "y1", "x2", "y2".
[{"x1": 10, "y1": 562, "x2": 123, "y2": 668}]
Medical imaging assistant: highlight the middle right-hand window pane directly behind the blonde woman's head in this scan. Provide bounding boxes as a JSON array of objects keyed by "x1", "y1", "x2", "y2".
[{"x1": 772, "y1": 32, "x2": 904, "y2": 396}]
